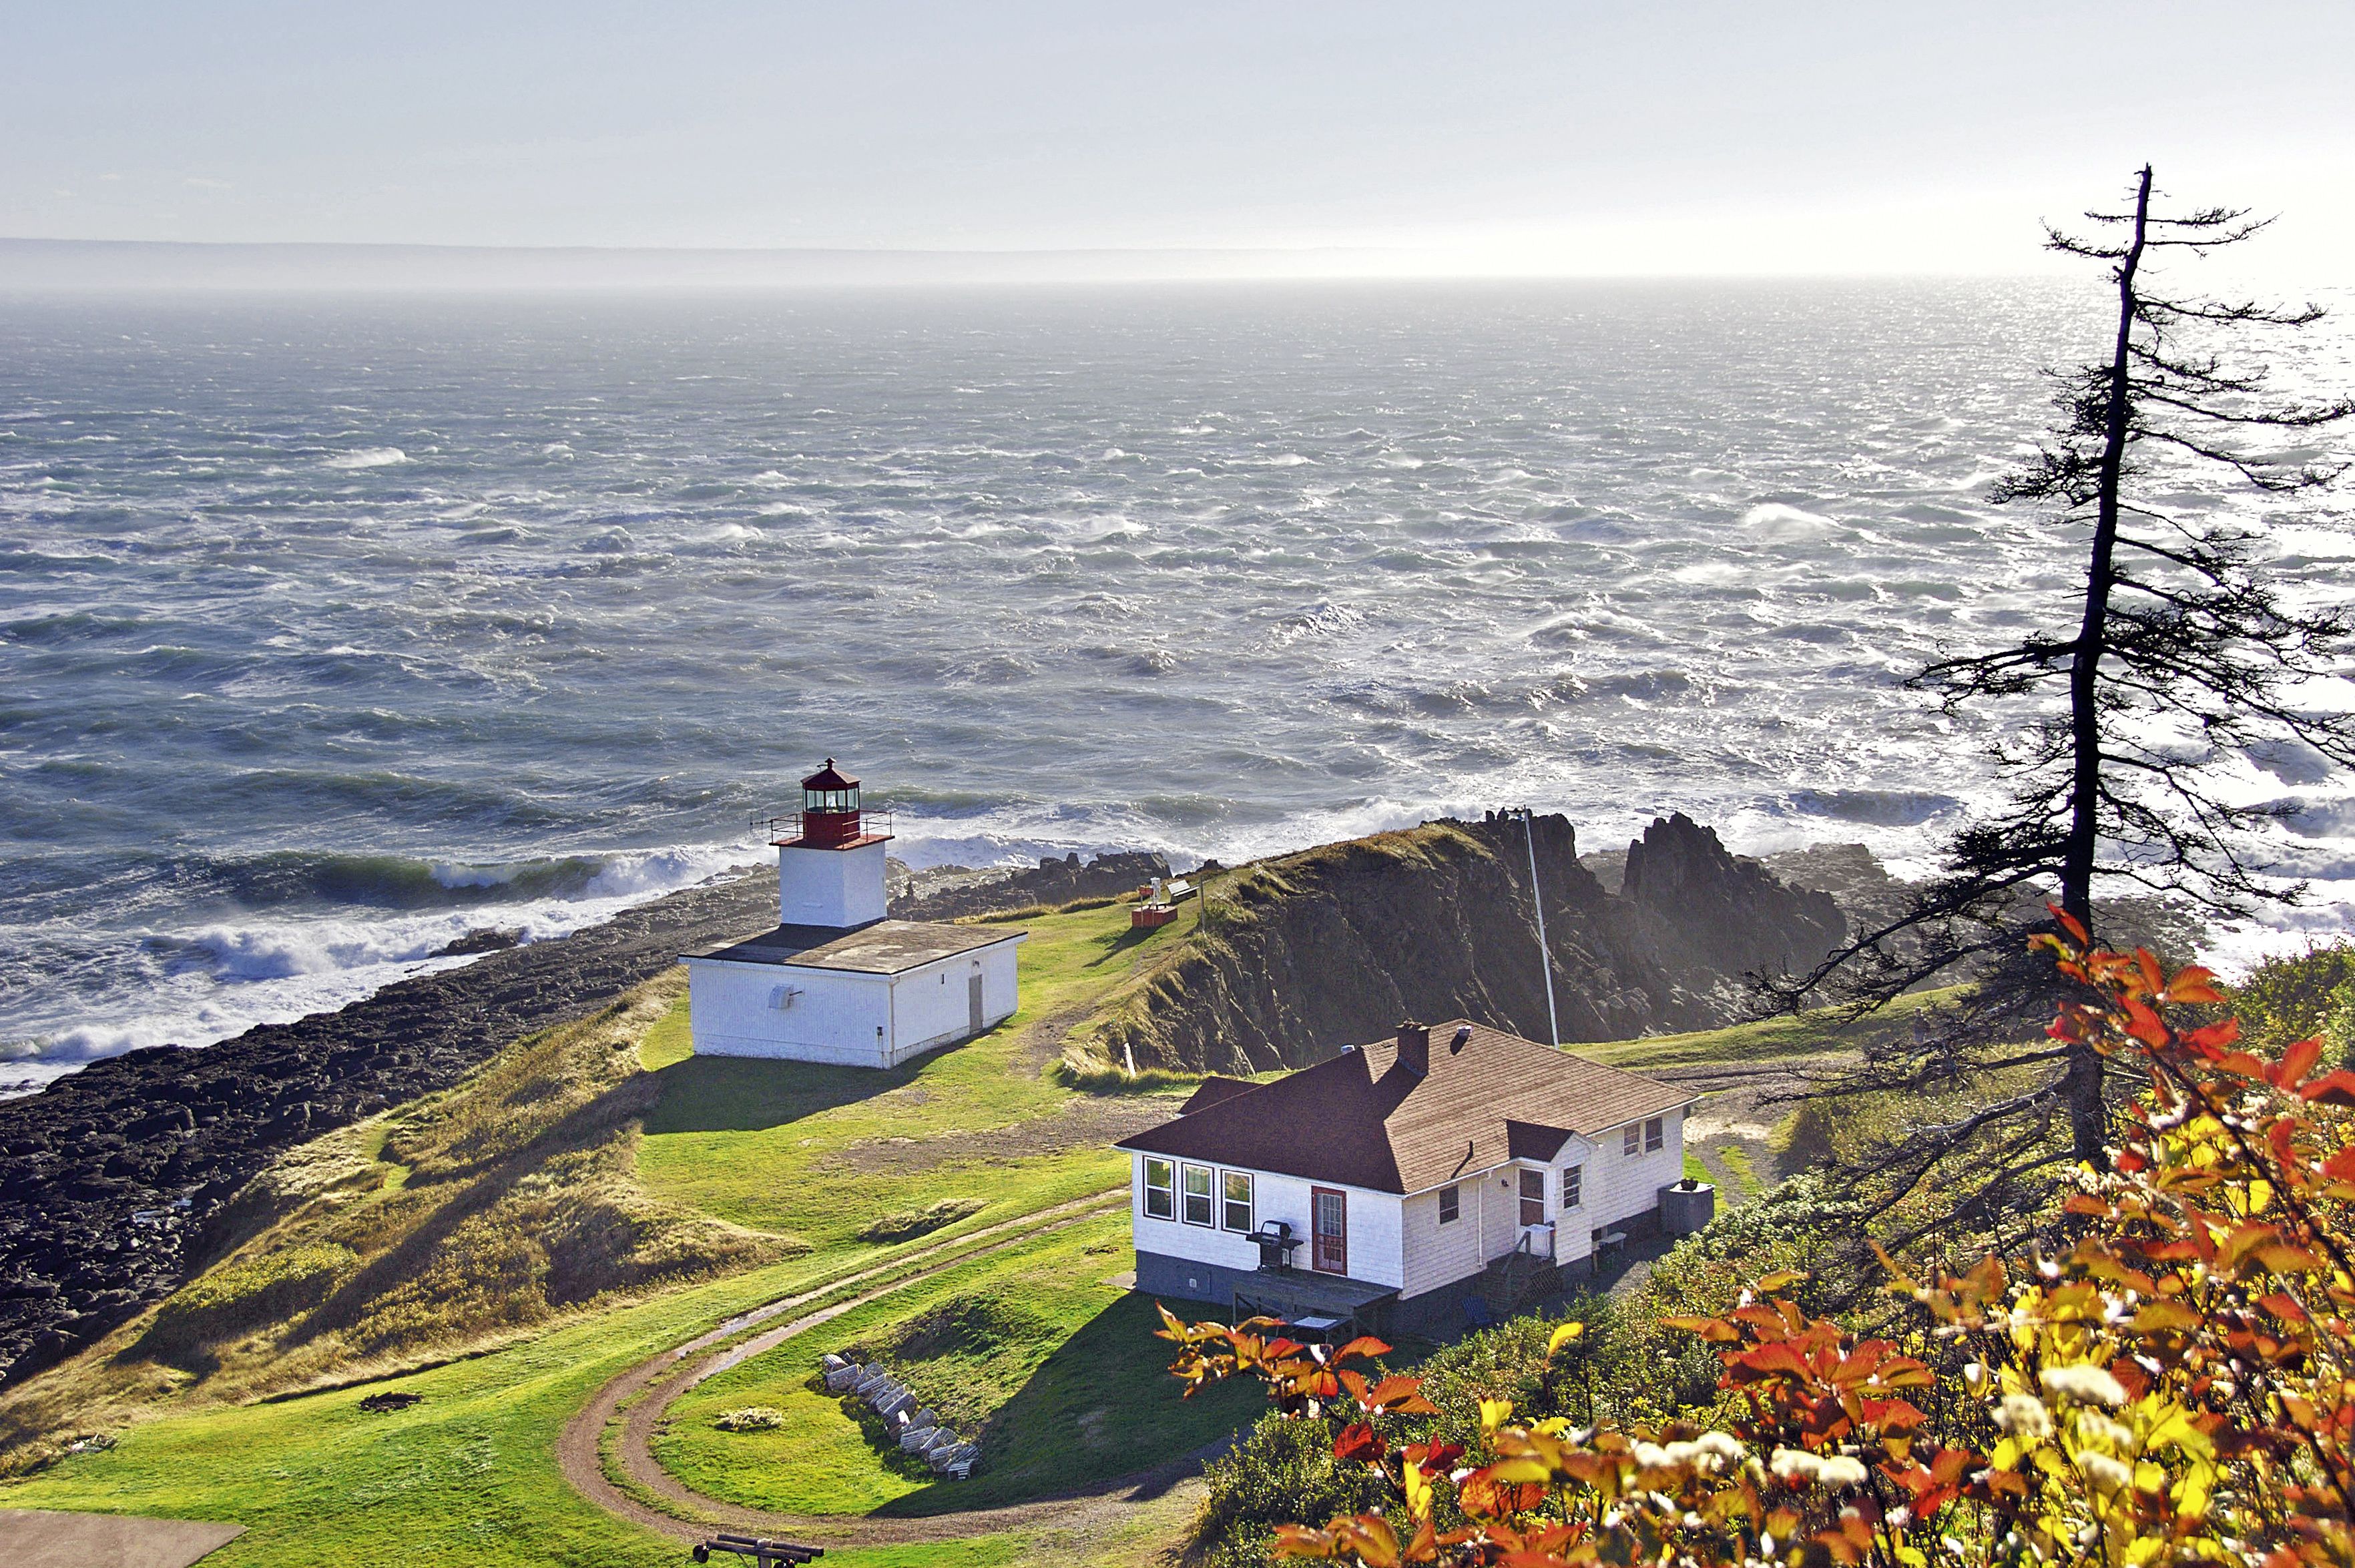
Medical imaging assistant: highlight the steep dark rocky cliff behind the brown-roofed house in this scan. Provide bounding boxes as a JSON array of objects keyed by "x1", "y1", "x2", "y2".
[{"x1": 1090, "y1": 817, "x2": 1842, "y2": 1071}]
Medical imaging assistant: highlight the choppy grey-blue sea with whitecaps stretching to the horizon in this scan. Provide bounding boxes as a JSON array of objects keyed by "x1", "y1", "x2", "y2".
[{"x1": 0, "y1": 280, "x2": 2355, "y2": 1087}]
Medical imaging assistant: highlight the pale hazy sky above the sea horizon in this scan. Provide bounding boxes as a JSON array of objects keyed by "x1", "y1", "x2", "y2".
[{"x1": 0, "y1": 0, "x2": 2355, "y2": 282}]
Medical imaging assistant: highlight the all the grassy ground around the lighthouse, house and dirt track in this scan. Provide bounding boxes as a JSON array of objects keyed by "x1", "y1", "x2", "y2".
[{"x1": 0, "y1": 880, "x2": 1912, "y2": 1568}]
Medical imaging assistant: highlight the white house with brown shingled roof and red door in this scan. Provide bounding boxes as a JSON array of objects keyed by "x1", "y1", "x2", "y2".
[{"x1": 1119, "y1": 1019, "x2": 1714, "y2": 1332}]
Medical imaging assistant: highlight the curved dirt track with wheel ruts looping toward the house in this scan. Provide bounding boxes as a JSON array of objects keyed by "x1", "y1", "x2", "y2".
[{"x1": 556, "y1": 1189, "x2": 1234, "y2": 1545}]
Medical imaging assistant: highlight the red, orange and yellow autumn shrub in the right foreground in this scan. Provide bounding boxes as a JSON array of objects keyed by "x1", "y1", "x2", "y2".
[{"x1": 1163, "y1": 916, "x2": 2355, "y2": 1568}]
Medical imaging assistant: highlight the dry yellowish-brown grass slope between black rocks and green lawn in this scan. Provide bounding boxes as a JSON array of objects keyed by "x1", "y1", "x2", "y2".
[{"x1": 0, "y1": 977, "x2": 791, "y2": 1460}]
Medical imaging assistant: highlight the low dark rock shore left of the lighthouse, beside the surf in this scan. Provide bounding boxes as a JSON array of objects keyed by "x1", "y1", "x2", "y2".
[{"x1": 0, "y1": 876, "x2": 777, "y2": 1382}]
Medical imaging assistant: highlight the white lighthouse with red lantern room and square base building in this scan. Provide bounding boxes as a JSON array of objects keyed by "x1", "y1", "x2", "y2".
[{"x1": 683, "y1": 756, "x2": 1027, "y2": 1067}]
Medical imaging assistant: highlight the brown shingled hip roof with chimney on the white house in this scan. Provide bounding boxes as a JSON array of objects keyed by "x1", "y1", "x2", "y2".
[{"x1": 1116, "y1": 1019, "x2": 1693, "y2": 1194}]
